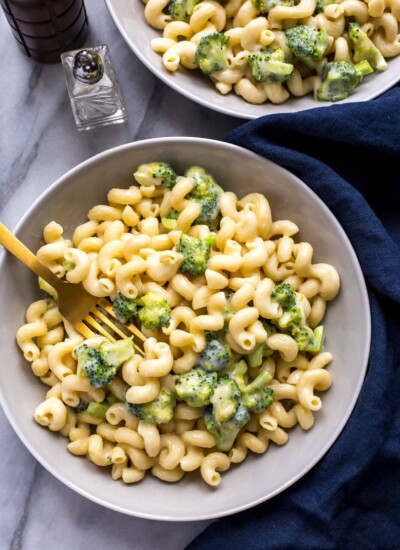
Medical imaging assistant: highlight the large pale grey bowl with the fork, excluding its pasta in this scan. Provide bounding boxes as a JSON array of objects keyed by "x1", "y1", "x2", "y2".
[{"x1": 0, "y1": 138, "x2": 370, "y2": 521}]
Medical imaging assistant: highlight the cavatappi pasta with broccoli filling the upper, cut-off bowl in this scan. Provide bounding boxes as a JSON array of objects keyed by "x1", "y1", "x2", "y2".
[{"x1": 144, "y1": 0, "x2": 400, "y2": 104}]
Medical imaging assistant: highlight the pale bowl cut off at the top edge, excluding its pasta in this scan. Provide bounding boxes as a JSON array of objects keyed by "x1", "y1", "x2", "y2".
[{"x1": 105, "y1": 0, "x2": 400, "y2": 119}]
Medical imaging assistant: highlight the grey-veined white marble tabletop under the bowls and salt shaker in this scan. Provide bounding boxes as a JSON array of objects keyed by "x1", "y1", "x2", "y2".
[{"x1": 0, "y1": 0, "x2": 241, "y2": 550}]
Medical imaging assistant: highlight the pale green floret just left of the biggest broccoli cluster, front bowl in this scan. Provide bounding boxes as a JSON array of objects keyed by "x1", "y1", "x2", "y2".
[{"x1": 175, "y1": 367, "x2": 217, "y2": 407}]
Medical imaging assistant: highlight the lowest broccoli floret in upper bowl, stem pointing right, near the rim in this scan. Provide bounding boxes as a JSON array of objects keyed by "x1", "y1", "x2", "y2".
[{"x1": 317, "y1": 61, "x2": 373, "y2": 101}]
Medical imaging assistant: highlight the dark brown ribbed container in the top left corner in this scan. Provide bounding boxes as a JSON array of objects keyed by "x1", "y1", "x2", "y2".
[{"x1": 0, "y1": 0, "x2": 88, "y2": 63}]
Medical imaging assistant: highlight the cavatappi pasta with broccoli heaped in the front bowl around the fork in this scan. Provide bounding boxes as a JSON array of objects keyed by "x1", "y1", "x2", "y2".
[{"x1": 17, "y1": 163, "x2": 340, "y2": 486}]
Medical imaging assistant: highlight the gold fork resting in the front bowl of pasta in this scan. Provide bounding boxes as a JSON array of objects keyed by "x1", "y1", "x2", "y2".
[{"x1": 0, "y1": 222, "x2": 146, "y2": 355}]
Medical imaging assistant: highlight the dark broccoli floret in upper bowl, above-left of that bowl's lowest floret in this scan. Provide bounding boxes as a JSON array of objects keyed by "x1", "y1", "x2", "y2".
[{"x1": 286, "y1": 25, "x2": 329, "y2": 67}]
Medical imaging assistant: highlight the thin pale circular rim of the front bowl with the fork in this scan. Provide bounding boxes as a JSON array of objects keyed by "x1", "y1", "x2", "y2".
[{"x1": 0, "y1": 137, "x2": 371, "y2": 522}]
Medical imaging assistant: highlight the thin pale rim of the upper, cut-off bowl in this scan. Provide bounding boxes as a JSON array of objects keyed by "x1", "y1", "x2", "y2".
[{"x1": 104, "y1": 0, "x2": 400, "y2": 120}]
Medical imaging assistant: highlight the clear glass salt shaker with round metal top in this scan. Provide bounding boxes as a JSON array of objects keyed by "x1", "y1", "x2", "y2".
[{"x1": 61, "y1": 44, "x2": 126, "y2": 130}]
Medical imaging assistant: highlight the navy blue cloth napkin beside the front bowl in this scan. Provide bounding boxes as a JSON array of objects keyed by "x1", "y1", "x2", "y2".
[{"x1": 188, "y1": 87, "x2": 400, "y2": 550}]
